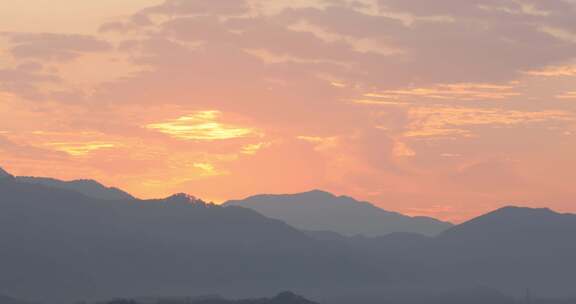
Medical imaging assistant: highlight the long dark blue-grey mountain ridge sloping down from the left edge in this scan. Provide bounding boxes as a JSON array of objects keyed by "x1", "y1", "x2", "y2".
[{"x1": 0, "y1": 179, "x2": 364, "y2": 302}]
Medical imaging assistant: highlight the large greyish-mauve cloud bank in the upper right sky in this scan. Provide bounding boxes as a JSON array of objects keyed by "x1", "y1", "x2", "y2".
[{"x1": 276, "y1": 0, "x2": 575, "y2": 85}]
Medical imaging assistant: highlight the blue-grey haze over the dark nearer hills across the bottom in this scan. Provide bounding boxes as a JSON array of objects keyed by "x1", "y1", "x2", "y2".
[{"x1": 0, "y1": 167, "x2": 576, "y2": 304}]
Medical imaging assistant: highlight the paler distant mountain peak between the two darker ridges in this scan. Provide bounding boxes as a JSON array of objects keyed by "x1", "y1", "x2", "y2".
[{"x1": 225, "y1": 190, "x2": 452, "y2": 237}]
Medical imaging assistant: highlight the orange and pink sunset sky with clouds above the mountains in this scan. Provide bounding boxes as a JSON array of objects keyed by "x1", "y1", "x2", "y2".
[{"x1": 0, "y1": 0, "x2": 576, "y2": 222}]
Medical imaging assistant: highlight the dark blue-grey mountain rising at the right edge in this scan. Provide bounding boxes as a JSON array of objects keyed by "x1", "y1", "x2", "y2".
[{"x1": 420, "y1": 207, "x2": 576, "y2": 296}]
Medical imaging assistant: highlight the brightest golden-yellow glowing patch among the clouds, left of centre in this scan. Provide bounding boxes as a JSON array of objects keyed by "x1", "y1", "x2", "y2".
[{"x1": 146, "y1": 110, "x2": 258, "y2": 141}]
